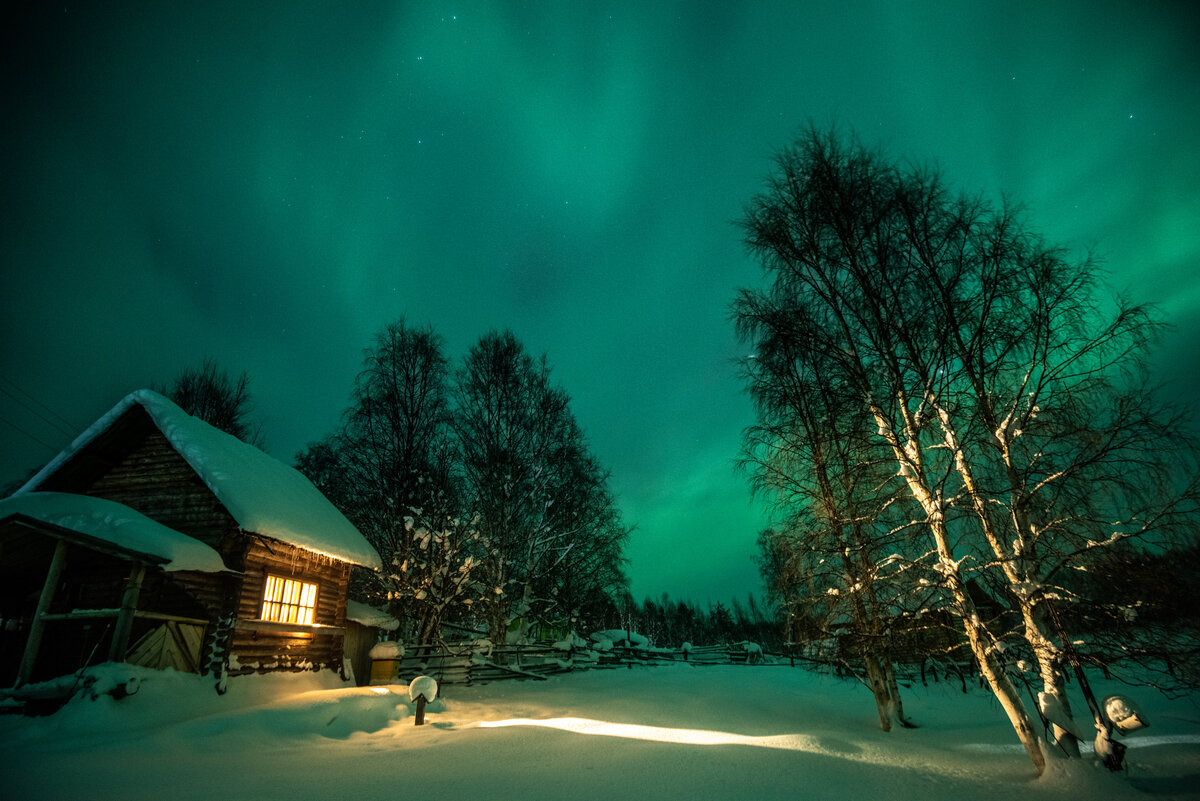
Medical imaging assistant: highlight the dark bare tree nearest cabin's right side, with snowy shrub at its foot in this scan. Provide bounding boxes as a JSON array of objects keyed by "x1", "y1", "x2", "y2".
[{"x1": 296, "y1": 320, "x2": 470, "y2": 643}]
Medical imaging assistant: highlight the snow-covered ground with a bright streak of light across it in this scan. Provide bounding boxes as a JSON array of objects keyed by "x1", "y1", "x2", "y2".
[{"x1": 0, "y1": 664, "x2": 1200, "y2": 801}]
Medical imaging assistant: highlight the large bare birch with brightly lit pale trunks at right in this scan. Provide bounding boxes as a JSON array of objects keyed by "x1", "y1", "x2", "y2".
[{"x1": 734, "y1": 131, "x2": 1196, "y2": 771}]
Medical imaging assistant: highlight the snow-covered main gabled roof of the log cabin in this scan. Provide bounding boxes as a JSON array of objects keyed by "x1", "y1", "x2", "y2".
[{"x1": 17, "y1": 390, "x2": 380, "y2": 568}]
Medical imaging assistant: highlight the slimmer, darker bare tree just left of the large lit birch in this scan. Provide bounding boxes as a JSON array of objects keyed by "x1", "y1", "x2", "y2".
[{"x1": 737, "y1": 314, "x2": 908, "y2": 731}]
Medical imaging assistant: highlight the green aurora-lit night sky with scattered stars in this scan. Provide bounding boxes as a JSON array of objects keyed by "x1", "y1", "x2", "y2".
[{"x1": 0, "y1": 0, "x2": 1200, "y2": 602}]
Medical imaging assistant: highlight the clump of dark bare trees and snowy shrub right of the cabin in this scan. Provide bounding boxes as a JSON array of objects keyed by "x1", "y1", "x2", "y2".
[{"x1": 296, "y1": 321, "x2": 629, "y2": 643}]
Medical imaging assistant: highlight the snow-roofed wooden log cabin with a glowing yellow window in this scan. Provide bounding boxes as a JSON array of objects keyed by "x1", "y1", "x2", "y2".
[{"x1": 0, "y1": 390, "x2": 379, "y2": 687}]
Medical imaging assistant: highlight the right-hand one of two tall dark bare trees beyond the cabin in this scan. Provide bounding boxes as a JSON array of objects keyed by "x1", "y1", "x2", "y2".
[{"x1": 454, "y1": 332, "x2": 628, "y2": 642}]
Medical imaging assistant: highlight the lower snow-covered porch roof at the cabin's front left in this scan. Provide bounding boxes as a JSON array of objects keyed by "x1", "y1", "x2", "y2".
[{"x1": 0, "y1": 493, "x2": 226, "y2": 572}]
